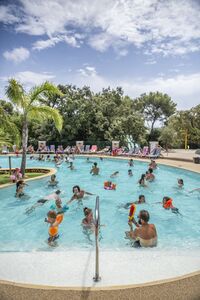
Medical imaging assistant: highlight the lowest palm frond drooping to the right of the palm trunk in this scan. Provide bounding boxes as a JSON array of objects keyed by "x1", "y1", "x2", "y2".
[{"x1": 28, "y1": 106, "x2": 63, "y2": 131}]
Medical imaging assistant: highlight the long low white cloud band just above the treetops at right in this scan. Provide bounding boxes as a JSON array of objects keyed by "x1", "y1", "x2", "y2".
[{"x1": 69, "y1": 68, "x2": 200, "y2": 109}]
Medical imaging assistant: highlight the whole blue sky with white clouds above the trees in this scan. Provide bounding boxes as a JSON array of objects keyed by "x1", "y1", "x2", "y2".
[{"x1": 0, "y1": 0, "x2": 200, "y2": 110}]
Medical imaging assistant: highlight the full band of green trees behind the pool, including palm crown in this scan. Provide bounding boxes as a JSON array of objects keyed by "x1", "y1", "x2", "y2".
[{"x1": 0, "y1": 79, "x2": 200, "y2": 157}]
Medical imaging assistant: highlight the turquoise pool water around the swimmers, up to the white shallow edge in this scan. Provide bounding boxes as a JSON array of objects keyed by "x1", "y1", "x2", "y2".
[{"x1": 0, "y1": 157, "x2": 200, "y2": 251}]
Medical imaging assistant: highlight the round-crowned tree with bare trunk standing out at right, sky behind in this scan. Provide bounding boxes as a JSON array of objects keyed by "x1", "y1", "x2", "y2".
[{"x1": 135, "y1": 92, "x2": 176, "y2": 139}]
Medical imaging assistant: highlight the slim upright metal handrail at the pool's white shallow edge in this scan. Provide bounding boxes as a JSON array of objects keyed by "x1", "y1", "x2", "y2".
[{"x1": 93, "y1": 196, "x2": 101, "y2": 282}]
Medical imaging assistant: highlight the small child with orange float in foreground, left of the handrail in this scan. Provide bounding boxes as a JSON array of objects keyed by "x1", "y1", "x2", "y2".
[{"x1": 45, "y1": 210, "x2": 60, "y2": 246}]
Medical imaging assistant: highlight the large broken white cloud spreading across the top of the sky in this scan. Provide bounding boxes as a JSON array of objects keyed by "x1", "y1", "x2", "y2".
[{"x1": 2, "y1": 0, "x2": 200, "y2": 56}]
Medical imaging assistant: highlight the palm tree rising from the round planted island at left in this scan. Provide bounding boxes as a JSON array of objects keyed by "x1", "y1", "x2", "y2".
[{"x1": 6, "y1": 79, "x2": 63, "y2": 176}]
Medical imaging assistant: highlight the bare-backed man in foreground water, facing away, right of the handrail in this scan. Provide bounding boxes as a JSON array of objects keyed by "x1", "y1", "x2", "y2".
[{"x1": 126, "y1": 210, "x2": 157, "y2": 247}]
